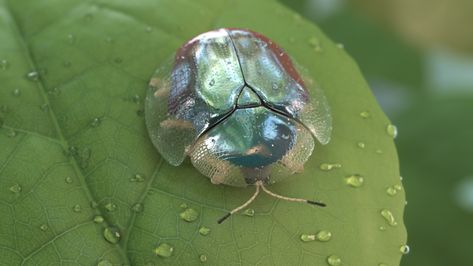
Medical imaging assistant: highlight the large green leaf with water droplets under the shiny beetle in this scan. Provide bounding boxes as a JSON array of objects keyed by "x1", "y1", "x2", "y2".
[{"x1": 0, "y1": 0, "x2": 406, "y2": 265}]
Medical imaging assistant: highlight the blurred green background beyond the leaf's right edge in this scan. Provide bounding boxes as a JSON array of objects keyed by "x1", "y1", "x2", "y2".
[{"x1": 281, "y1": 0, "x2": 473, "y2": 266}]
